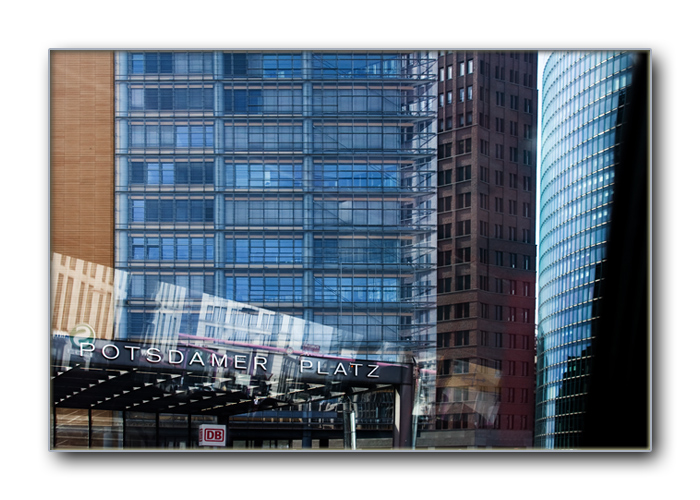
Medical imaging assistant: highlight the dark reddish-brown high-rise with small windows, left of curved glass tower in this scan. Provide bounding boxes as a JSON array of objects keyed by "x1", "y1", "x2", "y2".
[{"x1": 419, "y1": 51, "x2": 537, "y2": 448}]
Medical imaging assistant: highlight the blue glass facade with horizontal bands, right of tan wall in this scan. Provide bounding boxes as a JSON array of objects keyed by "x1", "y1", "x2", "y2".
[{"x1": 115, "y1": 51, "x2": 436, "y2": 432}]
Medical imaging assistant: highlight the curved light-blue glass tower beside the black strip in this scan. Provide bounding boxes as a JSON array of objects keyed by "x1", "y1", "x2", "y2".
[{"x1": 535, "y1": 51, "x2": 635, "y2": 448}]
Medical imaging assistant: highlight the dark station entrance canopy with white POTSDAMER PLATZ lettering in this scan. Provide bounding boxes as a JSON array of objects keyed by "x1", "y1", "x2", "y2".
[{"x1": 51, "y1": 336, "x2": 414, "y2": 416}]
